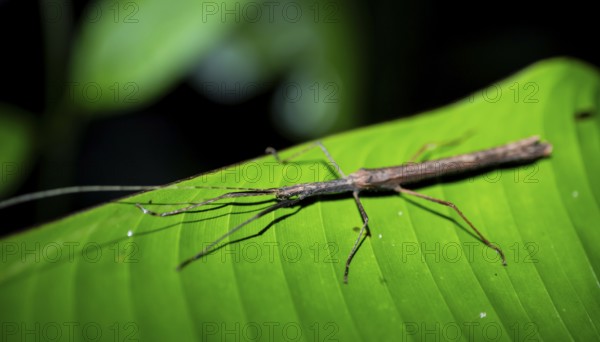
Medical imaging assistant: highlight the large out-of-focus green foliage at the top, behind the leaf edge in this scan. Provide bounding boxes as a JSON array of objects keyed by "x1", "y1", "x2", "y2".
[{"x1": 69, "y1": 0, "x2": 361, "y2": 139}]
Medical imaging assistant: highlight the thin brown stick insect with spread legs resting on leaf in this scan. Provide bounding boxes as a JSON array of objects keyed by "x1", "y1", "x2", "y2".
[{"x1": 137, "y1": 136, "x2": 552, "y2": 283}]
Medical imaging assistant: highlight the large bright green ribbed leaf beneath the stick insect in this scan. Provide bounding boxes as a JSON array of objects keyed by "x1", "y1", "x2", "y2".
[{"x1": 0, "y1": 59, "x2": 600, "y2": 341}]
